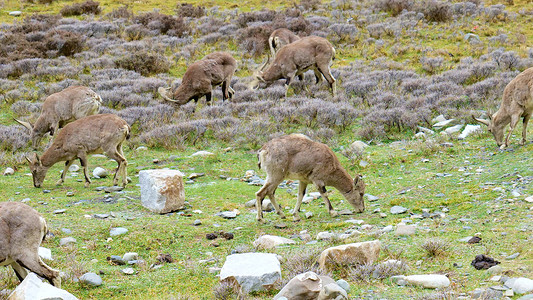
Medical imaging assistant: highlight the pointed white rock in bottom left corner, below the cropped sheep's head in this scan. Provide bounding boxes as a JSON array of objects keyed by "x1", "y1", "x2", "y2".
[{"x1": 7, "y1": 273, "x2": 78, "y2": 300}]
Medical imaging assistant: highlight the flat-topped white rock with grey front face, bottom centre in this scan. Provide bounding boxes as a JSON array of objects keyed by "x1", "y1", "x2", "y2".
[{"x1": 220, "y1": 253, "x2": 281, "y2": 293}]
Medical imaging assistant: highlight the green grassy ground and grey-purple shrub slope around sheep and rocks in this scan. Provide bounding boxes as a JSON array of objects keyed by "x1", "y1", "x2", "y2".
[{"x1": 0, "y1": 0, "x2": 533, "y2": 299}]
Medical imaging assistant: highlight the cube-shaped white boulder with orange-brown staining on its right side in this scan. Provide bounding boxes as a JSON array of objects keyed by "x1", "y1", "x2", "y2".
[{"x1": 139, "y1": 169, "x2": 185, "y2": 214}]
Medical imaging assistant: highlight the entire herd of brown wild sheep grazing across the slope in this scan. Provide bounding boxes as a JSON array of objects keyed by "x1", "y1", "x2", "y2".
[{"x1": 0, "y1": 25, "x2": 533, "y2": 287}]
